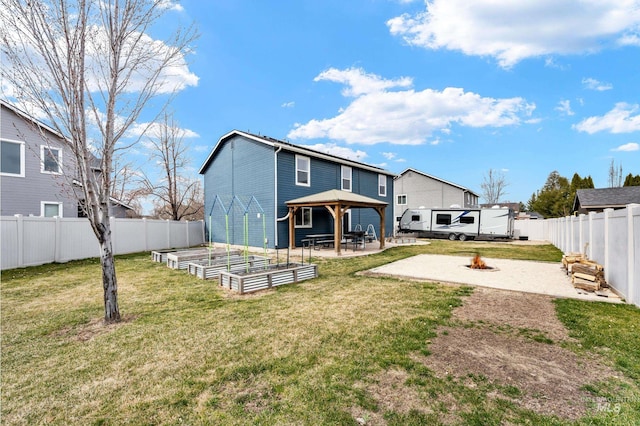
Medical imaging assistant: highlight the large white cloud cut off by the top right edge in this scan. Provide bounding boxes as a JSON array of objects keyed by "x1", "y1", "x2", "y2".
[{"x1": 387, "y1": 0, "x2": 640, "y2": 68}]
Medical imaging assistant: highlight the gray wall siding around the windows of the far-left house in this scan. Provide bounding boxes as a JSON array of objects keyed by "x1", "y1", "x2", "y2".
[{"x1": 0, "y1": 106, "x2": 78, "y2": 217}]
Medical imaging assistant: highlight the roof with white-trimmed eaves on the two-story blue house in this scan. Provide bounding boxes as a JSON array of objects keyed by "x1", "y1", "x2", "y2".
[{"x1": 198, "y1": 130, "x2": 395, "y2": 176}]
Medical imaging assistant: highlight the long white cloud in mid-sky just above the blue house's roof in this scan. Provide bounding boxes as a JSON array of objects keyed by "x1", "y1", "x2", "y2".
[{"x1": 288, "y1": 69, "x2": 535, "y2": 145}]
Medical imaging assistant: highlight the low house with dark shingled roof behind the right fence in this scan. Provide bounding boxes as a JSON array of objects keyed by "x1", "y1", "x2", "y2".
[{"x1": 571, "y1": 186, "x2": 640, "y2": 214}]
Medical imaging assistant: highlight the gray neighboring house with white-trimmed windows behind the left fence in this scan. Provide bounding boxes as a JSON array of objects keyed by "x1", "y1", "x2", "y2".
[{"x1": 0, "y1": 100, "x2": 133, "y2": 217}]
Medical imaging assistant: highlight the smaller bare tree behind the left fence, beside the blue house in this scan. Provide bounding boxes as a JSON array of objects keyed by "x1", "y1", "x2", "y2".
[{"x1": 144, "y1": 114, "x2": 204, "y2": 220}]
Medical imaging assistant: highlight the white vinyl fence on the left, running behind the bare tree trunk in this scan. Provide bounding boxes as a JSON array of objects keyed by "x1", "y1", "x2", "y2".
[{"x1": 0, "y1": 215, "x2": 205, "y2": 270}]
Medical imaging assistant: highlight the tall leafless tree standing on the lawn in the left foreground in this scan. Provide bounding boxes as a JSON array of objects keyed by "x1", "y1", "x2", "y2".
[{"x1": 0, "y1": 0, "x2": 195, "y2": 323}]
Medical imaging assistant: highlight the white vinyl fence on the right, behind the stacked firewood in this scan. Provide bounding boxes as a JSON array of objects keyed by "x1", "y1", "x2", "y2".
[{"x1": 515, "y1": 204, "x2": 640, "y2": 306}]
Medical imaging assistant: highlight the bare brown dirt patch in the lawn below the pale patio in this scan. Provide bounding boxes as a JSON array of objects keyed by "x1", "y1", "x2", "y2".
[{"x1": 419, "y1": 288, "x2": 615, "y2": 419}]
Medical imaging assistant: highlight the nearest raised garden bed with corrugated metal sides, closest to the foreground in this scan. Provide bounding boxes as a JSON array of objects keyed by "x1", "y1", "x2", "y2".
[{"x1": 220, "y1": 263, "x2": 318, "y2": 294}]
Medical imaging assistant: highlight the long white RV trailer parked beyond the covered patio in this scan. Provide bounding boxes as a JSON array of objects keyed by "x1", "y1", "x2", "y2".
[{"x1": 398, "y1": 207, "x2": 514, "y2": 241}]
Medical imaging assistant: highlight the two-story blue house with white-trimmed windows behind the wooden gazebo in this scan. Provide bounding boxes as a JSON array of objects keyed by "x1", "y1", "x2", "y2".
[{"x1": 199, "y1": 130, "x2": 394, "y2": 248}]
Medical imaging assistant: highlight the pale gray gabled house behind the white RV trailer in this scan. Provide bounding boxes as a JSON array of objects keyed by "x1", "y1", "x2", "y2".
[{"x1": 393, "y1": 168, "x2": 478, "y2": 223}]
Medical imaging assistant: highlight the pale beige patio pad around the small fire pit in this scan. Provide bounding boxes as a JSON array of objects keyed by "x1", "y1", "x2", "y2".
[{"x1": 365, "y1": 254, "x2": 621, "y2": 303}]
